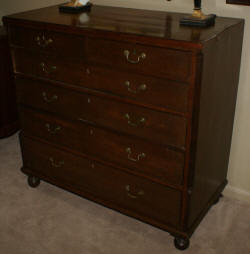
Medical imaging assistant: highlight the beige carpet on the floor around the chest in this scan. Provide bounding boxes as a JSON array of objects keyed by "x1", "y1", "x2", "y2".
[{"x1": 0, "y1": 135, "x2": 250, "y2": 254}]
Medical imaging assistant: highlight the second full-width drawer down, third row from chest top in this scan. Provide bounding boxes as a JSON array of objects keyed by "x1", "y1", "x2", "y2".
[{"x1": 17, "y1": 79, "x2": 187, "y2": 149}]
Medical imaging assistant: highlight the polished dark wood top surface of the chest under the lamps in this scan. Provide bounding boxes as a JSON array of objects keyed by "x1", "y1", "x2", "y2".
[{"x1": 3, "y1": 5, "x2": 244, "y2": 47}]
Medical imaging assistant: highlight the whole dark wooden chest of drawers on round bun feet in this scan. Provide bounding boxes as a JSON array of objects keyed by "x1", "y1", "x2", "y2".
[{"x1": 4, "y1": 6, "x2": 244, "y2": 249}]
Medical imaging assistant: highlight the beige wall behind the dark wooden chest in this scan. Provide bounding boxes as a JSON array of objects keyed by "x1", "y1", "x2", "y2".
[{"x1": 0, "y1": 0, "x2": 250, "y2": 200}]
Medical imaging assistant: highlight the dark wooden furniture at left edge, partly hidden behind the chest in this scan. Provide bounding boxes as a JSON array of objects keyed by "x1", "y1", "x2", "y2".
[{"x1": 0, "y1": 27, "x2": 19, "y2": 138}]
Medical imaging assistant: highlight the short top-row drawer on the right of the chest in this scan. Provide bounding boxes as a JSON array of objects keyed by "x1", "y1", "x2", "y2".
[{"x1": 87, "y1": 38, "x2": 191, "y2": 81}]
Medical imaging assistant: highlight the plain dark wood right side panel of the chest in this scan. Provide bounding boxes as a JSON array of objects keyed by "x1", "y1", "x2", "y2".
[{"x1": 189, "y1": 17, "x2": 244, "y2": 232}]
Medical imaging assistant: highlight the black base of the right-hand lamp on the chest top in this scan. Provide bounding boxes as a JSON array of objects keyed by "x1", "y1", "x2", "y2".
[{"x1": 180, "y1": 14, "x2": 216, "y2": 27}]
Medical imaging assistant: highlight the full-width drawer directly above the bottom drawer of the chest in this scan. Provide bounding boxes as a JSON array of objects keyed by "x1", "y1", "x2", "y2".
[{"x1": 20, "y1": 107, "x2": 184, "y2": 185}]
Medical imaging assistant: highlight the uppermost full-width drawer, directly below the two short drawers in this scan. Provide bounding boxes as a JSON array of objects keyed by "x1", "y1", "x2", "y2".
[{"x1": 12, "y1": 49, "x2": 189, "y2": 113}]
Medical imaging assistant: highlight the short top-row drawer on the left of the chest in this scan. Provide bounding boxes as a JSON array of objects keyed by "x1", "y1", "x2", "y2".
[{"x1": 9, "y1": 26, "x2": 86, "y2": 58}]
